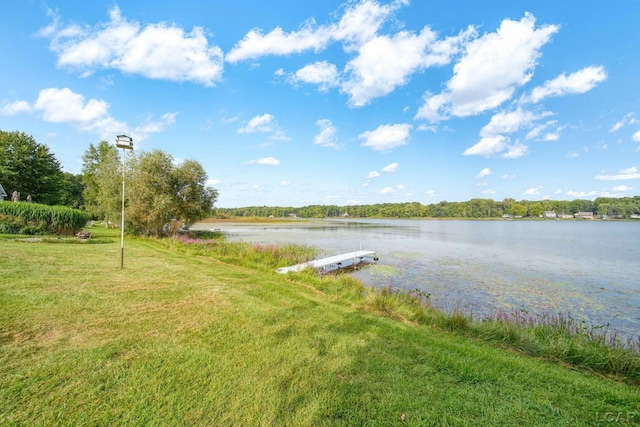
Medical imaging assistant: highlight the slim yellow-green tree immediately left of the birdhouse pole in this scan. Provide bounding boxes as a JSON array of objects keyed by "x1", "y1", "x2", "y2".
[{"x1": 82, "y1": 141, "x2": 122, "y2": 222}]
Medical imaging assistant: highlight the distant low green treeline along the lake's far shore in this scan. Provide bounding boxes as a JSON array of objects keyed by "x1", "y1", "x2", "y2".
[{"x1": 214, "y1": 196, "x2": 640, "y2": 218}]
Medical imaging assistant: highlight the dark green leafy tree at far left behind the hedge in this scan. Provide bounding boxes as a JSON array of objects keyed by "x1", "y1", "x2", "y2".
[{"x1": 0, "y1": 131, "x2": 64, "y2": 205}]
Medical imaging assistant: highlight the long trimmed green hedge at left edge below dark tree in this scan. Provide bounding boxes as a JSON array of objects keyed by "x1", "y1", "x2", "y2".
[{"x1": 0, "y1": 201, "x2": 89, "y2": 235}]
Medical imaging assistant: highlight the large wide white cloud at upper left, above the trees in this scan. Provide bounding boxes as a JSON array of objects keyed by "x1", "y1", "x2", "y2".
[{"x1": 40, "y1": 6, "x2": 223, "y2": 86}]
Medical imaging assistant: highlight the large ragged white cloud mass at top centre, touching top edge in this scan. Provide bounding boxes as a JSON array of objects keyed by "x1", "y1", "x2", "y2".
[{"x1": 226, "y1": 0, "x2": 476, "y2": 107}]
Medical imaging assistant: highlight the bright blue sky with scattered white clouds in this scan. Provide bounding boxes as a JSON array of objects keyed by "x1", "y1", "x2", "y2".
[{"x1": 0, "y1": 0, "x2": 640, "y2": 207}]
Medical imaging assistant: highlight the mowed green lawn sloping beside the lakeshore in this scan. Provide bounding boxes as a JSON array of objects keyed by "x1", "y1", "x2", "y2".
[{"x1": 0, "y1": 229, "x2": 640, "y2": 426}]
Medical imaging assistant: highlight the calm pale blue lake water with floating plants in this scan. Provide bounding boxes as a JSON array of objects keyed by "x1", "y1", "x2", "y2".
[{"x1": 198, "y1": 220, "x2": 640, "y2": 337}]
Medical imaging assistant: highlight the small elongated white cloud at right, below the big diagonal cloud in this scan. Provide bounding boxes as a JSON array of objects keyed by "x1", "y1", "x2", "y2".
[{"x1": 525, "y1": 66, "x2": 607, "y2": 103}]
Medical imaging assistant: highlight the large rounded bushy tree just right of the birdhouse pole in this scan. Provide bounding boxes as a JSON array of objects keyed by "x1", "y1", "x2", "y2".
[{"x1": 126, "y1": 150, "x2": 218, "y2": 236}]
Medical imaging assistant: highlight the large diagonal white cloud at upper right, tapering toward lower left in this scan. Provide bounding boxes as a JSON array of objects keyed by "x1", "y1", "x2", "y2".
[{"x1": 416, "y1": 13, "x2": 559, "y2": 121}]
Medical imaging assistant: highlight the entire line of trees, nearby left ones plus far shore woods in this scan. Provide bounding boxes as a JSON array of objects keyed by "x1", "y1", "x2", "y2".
[{"x1": 0, "y1": 130, "x2": 640, "y2": 229}]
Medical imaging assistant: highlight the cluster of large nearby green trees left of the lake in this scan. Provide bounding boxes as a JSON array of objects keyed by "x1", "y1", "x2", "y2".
[{"x1": 0, "y1": 131, "x2": 218, "y2": 236}]
